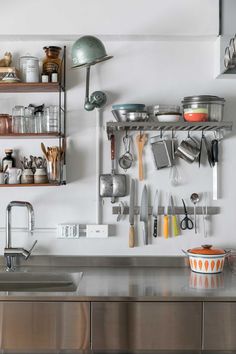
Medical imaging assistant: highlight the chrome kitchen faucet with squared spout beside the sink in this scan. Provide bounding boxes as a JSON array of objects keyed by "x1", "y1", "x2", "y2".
[{"x1": 4, "y1": 201, "x2": 37, "y2": 271}]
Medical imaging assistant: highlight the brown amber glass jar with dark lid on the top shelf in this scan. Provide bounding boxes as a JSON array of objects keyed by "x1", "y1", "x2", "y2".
[{"x1": 43, "y1": 46, "x2": 61, "y2": 78}]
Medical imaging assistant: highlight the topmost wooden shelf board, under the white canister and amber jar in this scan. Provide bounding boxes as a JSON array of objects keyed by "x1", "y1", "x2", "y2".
[{"x1": 0, "y1": 81, "x2": 64, "y2": 93}]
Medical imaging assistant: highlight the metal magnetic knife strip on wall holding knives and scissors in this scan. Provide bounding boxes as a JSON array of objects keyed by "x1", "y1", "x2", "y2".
[{"x1": 112, "y1": 206, "x2": 220, "y2": 215}]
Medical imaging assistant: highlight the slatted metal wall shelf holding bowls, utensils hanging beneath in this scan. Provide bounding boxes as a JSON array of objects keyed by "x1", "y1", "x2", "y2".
[{"x1": 106, "y1": 121, "x2": 233, "y2": 137}]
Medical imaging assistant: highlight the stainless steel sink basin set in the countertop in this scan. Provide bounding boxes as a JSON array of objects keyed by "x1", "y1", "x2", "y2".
[{"x1": 0, "y1": 271, "x2": 83, "y2": 292}]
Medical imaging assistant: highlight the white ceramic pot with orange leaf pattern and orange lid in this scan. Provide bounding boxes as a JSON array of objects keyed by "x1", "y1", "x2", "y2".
[{"x1": 183, "y1": 245, "x2": 230, "y2": 274}]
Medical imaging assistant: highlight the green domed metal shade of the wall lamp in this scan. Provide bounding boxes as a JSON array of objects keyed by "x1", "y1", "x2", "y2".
[{"x1": 72, "y1": 36, "x2": 112, "y2": 68}]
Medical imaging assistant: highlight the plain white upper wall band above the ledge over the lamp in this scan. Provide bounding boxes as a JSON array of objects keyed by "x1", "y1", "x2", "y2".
[{"x1": 0, "y1": 0, "x2": 219, "y2": 38}]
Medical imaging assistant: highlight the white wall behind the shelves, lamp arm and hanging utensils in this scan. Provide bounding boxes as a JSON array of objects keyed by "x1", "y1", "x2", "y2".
[{"x1": 0, "y1": 0, "x2": 236, "y2": 255}]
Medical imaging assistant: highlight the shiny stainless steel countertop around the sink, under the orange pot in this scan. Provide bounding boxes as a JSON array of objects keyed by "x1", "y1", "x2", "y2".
[{"x1": 0, "y1": 266, "x2": 236, "y2": 301}]
